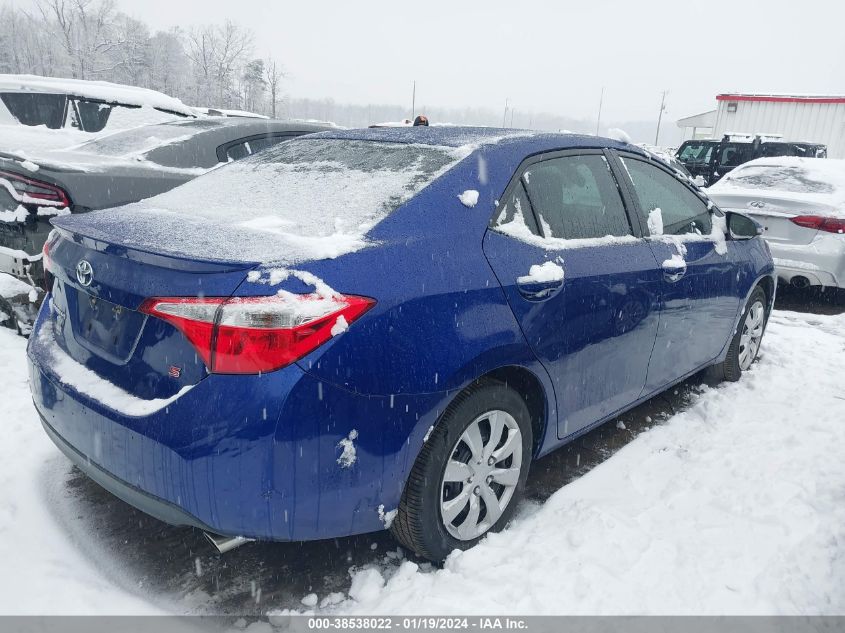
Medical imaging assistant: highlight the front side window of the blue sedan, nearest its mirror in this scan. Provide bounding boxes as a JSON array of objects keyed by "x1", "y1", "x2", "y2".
[{"x1": 622, "y1": 157, "x2": 711, "y2": 235}]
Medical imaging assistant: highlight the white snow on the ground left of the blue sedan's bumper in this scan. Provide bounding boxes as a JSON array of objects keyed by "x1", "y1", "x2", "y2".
[{"x1": 0, "y1": 327, "x2": 168, "y2": 615}]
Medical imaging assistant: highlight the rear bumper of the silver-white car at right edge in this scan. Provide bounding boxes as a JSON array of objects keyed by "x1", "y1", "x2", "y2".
[{"x1": 769, "y1": 234, "x2": 845, "y2": 288}]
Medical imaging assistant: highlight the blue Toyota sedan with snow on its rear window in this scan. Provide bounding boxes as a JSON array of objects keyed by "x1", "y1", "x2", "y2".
[{"x1": 28, "y1": 127, "x2": 775, "y2": 561}]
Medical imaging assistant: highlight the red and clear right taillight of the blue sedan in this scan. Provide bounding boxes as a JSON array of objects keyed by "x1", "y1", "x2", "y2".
[{"x1": 140, "y1": 292, "x2": 376, "y2": 374}]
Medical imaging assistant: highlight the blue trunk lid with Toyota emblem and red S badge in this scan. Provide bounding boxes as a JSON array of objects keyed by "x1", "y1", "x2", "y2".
[{"x1": 46, "y1": 222, "x2": 254, "y2": 399}]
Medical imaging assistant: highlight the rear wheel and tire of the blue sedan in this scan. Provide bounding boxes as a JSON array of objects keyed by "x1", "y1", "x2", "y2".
[{"x1": 390, "y1": 380, "x2": 534, "y2": 562}]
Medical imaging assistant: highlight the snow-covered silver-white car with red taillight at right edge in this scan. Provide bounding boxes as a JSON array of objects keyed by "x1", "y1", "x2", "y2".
[{"x1": 706, "y1": 157, "x2": 845, "y2": 288}]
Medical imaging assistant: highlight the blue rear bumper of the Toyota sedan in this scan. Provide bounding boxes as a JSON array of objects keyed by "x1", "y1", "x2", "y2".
[{"x1": 28, "y1": 310, "x2": 446, "y2": 541}]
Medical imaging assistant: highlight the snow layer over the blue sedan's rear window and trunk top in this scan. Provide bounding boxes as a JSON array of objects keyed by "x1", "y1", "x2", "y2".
[{"x1": 97, "y1": 138, "x2": 467, "y2": 263}]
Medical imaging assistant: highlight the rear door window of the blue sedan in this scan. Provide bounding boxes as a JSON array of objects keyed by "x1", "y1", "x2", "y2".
[{"x1": 522, "y1": 154, "x2": 631, "y2": 239}]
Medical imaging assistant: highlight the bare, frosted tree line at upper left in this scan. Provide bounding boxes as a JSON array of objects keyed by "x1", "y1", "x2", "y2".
[{"x1": 0, "y1": 0, "x2": 284, "y2": 116}]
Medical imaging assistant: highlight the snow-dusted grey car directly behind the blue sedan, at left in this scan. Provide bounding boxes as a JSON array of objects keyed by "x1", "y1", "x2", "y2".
[{"x1": 0, "y1": 117, "x2": 336, "y2": 328}]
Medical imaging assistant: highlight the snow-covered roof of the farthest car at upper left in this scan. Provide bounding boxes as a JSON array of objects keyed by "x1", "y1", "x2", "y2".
[{"x1": 0, "y1": 74, "x2": 196, "y2": 117}]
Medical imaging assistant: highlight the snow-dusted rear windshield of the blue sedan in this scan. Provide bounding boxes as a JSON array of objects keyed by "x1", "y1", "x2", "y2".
[{"x1": 134, "y1": 137, "x2": 466, "y2": 249}]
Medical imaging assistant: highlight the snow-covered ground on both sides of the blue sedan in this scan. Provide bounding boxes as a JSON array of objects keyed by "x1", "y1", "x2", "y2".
[{"x1": 0, "y1": 311, "x2": 845, "y2": 614}]
